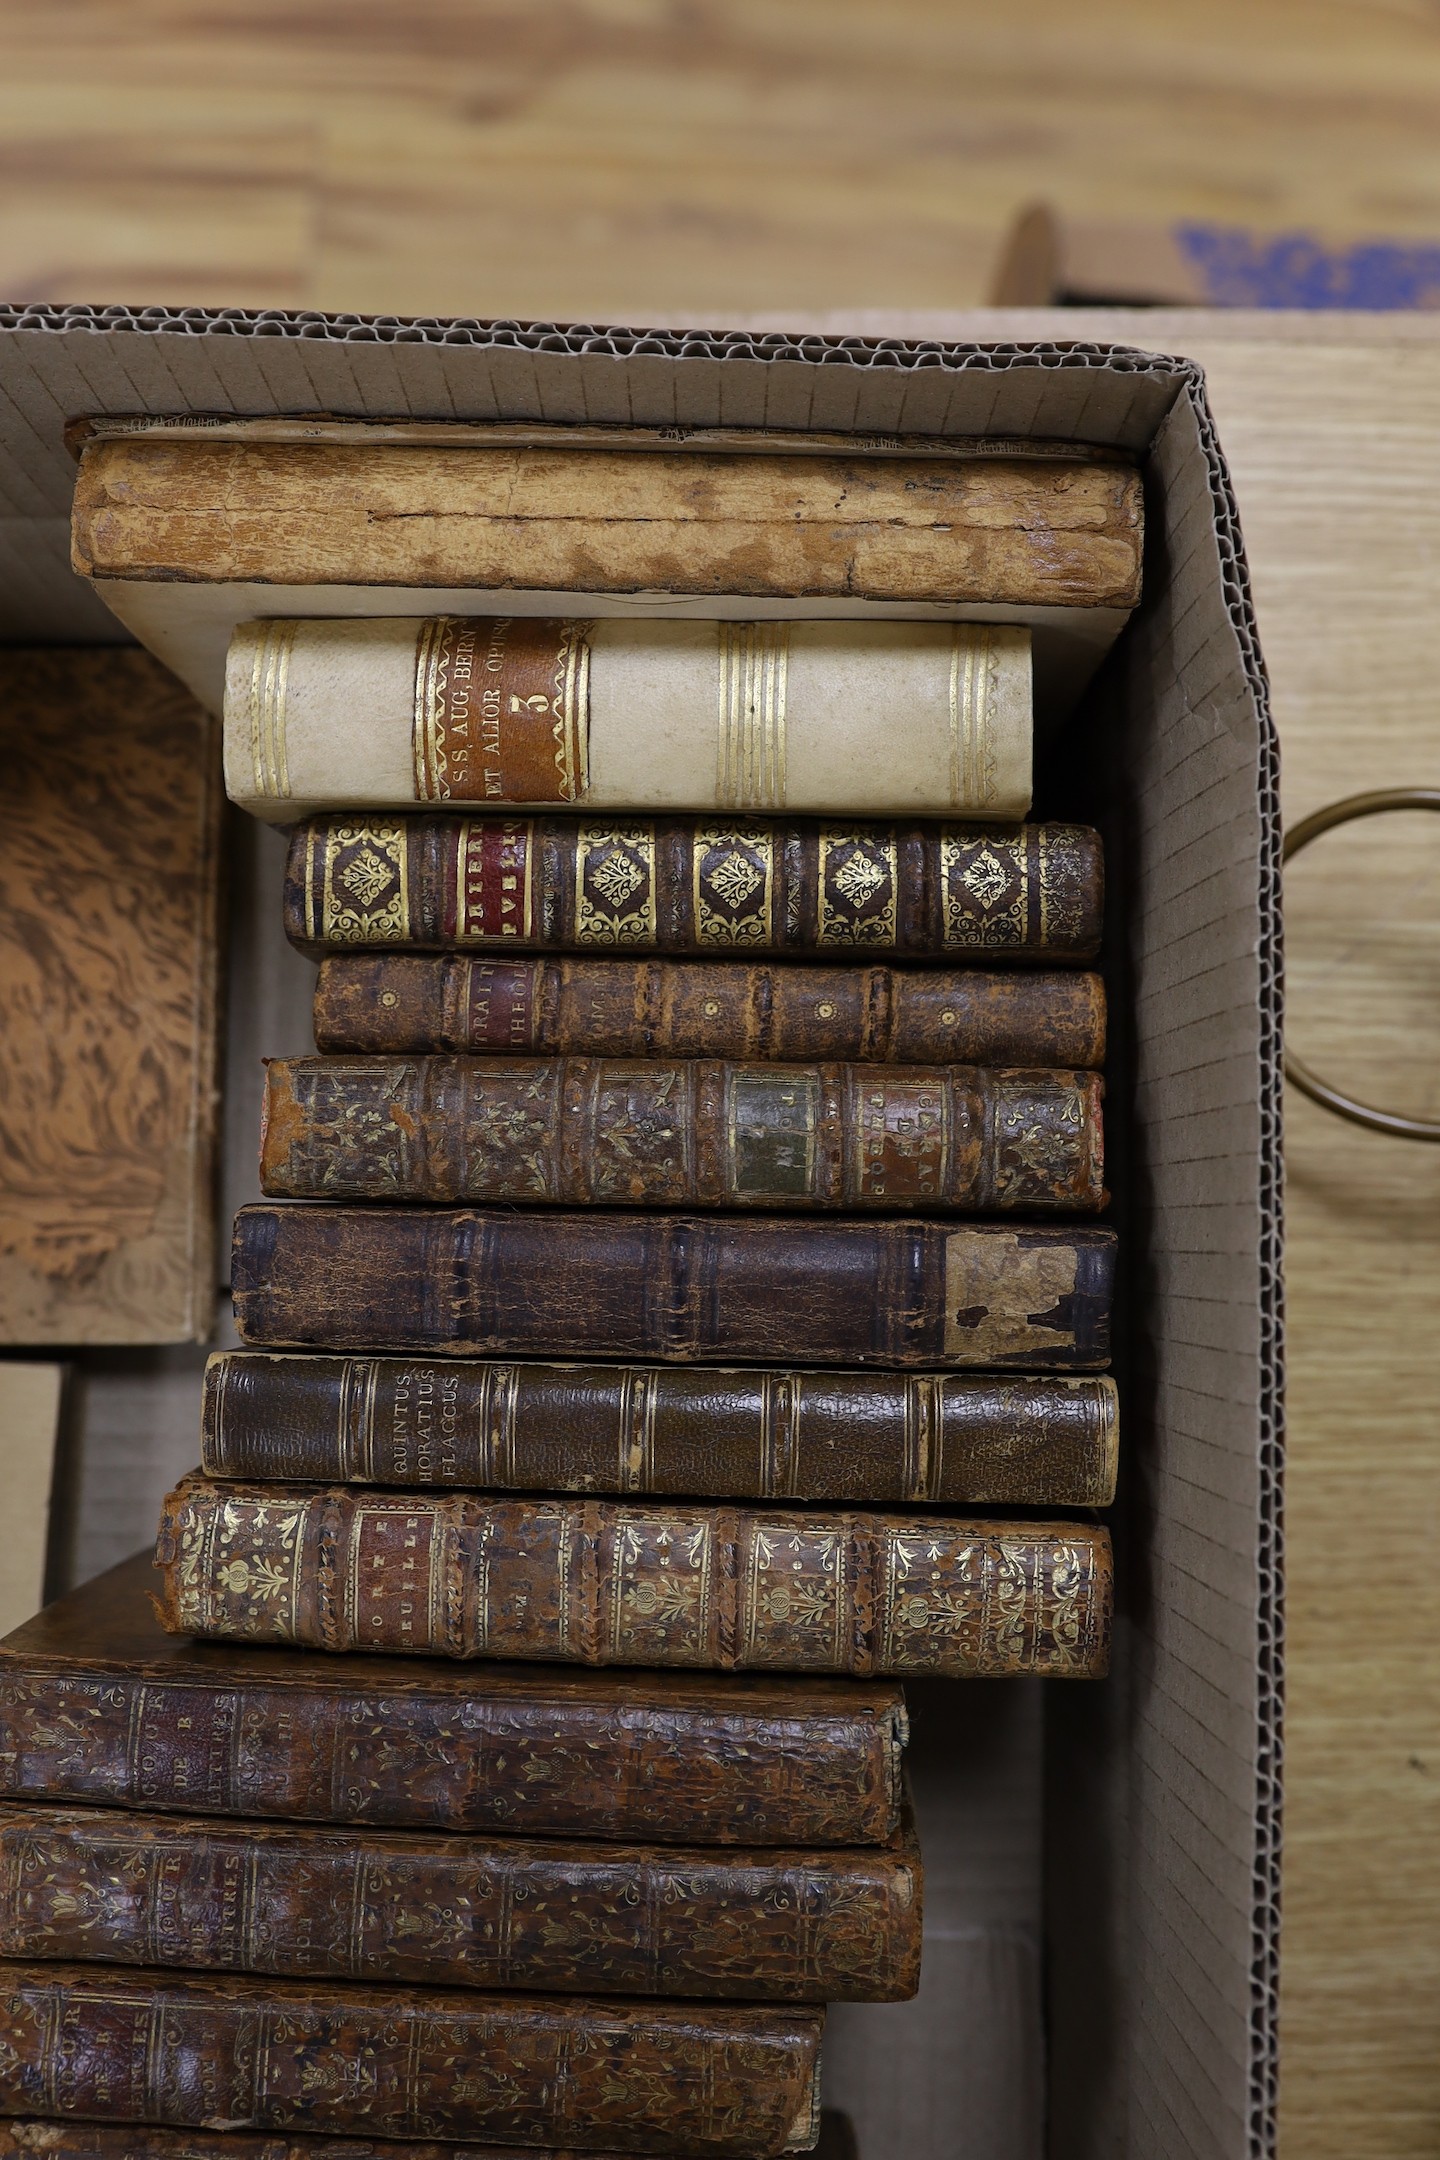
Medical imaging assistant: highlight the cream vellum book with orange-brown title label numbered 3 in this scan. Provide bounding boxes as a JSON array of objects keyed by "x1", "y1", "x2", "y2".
[{"x1": 225, "y1": 616, "x2": 1032, "y2": 825}]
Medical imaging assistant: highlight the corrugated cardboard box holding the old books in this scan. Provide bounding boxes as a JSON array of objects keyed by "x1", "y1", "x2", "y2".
[{"x1": 0, "y1": 307, "x2": 1280, "y2": 2160}]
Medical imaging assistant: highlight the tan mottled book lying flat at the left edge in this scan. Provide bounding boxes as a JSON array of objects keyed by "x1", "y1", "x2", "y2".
[{"x1": 0, "y1": 648, "x2": 225, "y2": 1346}]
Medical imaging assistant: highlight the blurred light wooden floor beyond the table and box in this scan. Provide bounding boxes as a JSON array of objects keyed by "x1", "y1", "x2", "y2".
[{"x1": 0, "y1": 0, "x2": 1440, "y2": 324}]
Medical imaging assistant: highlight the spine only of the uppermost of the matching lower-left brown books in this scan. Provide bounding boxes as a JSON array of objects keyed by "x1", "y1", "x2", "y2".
[{"x1": 0, "y1": 1665, "x2": 905, "y2": 1847}]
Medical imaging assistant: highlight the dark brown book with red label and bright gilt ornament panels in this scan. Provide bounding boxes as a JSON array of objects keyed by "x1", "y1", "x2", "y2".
[{"x1": 285, "y1": 812, "x2": 1103, "y2": 966}]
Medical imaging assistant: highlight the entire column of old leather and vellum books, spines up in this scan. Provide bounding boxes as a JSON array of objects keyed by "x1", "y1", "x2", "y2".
[{"x1": 0, "y1": 434, "x2": 1140, "y2": 2160}]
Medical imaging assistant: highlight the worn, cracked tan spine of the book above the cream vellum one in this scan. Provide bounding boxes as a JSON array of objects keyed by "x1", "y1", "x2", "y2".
[{"x1": 71, "y1": 441, "x2": 1142, "y2": 607}]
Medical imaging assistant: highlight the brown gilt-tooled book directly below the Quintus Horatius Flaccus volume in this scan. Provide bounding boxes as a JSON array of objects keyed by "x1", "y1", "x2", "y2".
[{"x1": 155, "y1": 1473, "x2": 1114, "y2": 1678}]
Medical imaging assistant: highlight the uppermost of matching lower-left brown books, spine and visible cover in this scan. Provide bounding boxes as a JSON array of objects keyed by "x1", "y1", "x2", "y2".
[{"x1": 0, "y1": 1553, "x2": 905, "y2": 1847}]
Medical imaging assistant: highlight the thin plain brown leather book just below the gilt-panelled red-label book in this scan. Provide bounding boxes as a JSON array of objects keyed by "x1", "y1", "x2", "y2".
[{"x1": 315, "y1": 953, "x2": 1105, "y2": 1067}]
